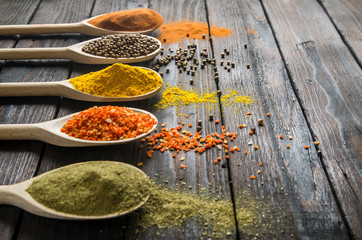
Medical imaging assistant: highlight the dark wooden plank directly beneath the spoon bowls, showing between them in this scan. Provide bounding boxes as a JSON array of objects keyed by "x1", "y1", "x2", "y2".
[{"x1": 14, "y1": 1, "x2": 235, "y2": 239}]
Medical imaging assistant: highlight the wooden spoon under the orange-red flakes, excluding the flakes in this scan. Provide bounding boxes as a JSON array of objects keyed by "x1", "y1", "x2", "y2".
[{"x1": 0, "y1": 108, "x2": 157, "y2": 147}]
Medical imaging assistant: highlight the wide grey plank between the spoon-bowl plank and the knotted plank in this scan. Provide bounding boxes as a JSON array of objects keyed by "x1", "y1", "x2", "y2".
[{"x1": 207, "y1": 0, "x2": 348, "y2": 239}]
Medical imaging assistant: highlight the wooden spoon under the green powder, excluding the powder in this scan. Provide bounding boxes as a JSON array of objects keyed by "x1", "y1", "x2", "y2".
[{"x1": 0, "y1": 162, "x2": 149, "y2": 220}]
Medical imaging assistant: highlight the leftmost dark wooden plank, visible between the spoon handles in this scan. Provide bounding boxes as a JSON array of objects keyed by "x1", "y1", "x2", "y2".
[{"x1": 0, "y1": 1, "x2": 95, "y2": 239}]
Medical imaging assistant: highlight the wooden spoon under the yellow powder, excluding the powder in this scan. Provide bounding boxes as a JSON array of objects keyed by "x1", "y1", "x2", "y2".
[{"x1": 0, "y1": 68, "x2": 162, "y2": 102}]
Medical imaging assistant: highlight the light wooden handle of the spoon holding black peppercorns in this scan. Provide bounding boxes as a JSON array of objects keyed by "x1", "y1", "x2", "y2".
[{"x1": 0, "y1": 47, "x2": 73, "y2": 60}]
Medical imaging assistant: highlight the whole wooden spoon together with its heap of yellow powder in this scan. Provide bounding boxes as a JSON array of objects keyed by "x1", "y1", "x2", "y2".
[{"x1": 0, "y1": 63, "x2": 163, "y2": 102}]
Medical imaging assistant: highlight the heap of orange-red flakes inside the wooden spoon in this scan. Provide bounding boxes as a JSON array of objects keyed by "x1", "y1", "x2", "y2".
[{"x1": 61, "y1": 106, "x2": 157, "y2": 141}]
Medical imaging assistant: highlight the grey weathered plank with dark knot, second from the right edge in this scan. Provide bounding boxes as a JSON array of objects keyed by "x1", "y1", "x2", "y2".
[{"x1": 264, "y1": 0, "x2": 362, "y2": 239}]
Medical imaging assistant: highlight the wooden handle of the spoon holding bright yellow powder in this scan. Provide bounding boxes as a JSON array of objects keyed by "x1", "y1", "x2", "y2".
[{"x1": 0, "y1": 82, "x2": 63, "y2": 97}]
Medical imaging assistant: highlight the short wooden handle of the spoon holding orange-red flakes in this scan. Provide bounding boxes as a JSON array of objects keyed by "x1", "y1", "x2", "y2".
[{"x1": 0, "y1": 123, "x2": 43, "y2": 140}]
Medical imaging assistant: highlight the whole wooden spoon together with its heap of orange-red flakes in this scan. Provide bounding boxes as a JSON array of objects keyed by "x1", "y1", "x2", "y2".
[{"x1": 0, "y1": 106, "x2": 157, "y2": 147}]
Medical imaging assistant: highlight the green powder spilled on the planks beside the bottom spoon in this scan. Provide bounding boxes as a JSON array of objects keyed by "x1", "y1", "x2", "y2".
[{"x1": 135, "y1": 184, "x2": 285, "y2": 239}]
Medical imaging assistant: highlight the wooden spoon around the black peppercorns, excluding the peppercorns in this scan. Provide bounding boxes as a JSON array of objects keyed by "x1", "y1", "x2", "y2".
[{"x1": 0, "y1": 35, "x2": 162, "y2": 64}]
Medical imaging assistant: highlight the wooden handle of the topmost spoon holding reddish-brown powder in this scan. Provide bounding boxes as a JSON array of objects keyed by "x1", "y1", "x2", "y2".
[{"x1": 0, "y1": 22, "x2": 83, "y2": 35}]
